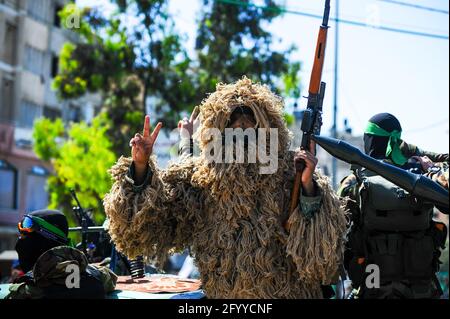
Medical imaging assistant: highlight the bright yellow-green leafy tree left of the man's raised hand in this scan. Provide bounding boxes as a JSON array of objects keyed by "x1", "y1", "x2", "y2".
[{"x1": 33, "y1": 113, "x2": 116, "y2": 228}]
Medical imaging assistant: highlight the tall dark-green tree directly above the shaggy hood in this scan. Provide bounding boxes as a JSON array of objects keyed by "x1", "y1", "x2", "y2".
[{"x1": 196, "y1": 0, "x2": 300, "y2": 98}]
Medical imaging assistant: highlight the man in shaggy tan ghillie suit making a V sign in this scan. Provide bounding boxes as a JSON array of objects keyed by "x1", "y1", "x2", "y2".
[{"x1": 104, "y1": 78, "x2": 346, "y2": 298}]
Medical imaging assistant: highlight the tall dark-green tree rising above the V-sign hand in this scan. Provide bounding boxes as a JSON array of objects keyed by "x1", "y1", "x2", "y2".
[{"x1": 53, "y1": 0, "x2": 194, "y2": 154}]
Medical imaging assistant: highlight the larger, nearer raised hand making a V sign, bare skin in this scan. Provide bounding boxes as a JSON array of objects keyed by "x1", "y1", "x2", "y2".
[{"x1": 130, "y1": 115, "x2": 162, "y2": 179}]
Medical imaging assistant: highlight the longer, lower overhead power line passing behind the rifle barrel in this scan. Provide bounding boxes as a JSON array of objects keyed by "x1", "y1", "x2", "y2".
[{"x1": 216, "y1": 0, "x2": 448, "y2": 40}]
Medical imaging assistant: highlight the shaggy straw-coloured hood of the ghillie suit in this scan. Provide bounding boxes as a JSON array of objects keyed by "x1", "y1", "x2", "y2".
[{"x1": 192, "y1": 77, "x2": 292, "y2": 225}]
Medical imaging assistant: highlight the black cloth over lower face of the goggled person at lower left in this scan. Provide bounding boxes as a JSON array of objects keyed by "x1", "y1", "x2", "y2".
[{"x1": 15, "y1": 233, "x2": 59, "y2": 273}]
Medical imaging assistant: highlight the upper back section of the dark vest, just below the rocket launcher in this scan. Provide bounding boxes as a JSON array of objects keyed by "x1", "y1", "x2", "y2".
[{"x1": 360, "y1": 172, "x2": 432, "y2": 232}]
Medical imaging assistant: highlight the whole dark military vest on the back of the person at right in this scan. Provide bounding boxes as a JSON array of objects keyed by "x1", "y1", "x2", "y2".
[{"x1": 348, "y1": 168, "x2": 446, "y2": 298}]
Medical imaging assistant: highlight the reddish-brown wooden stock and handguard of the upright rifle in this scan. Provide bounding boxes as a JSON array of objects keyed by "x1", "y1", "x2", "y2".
[{"x1": 285, "y1": 0, "x2": 330, "y2": 231}]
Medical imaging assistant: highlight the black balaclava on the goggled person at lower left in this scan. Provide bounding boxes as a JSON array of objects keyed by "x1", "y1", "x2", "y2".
[{"x1": 16, "y1": 210, "x2": 69, "y2": 273}]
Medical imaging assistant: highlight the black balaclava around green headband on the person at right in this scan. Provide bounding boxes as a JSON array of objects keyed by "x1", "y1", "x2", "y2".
[{"x1": 364, "y1": 113, "x2": 402, "y2": 159}]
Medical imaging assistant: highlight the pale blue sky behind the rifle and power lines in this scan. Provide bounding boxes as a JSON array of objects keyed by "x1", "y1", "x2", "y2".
[{"x1": 77, "y1": 0, "x2": 449, "y2": 152}]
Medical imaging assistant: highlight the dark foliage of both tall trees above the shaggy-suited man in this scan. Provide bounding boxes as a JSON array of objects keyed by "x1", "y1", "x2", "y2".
[{"x1": 54, "y1": 0, "x2": 300, "y2": 139}]
